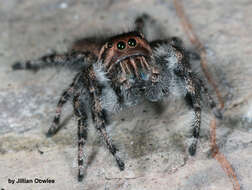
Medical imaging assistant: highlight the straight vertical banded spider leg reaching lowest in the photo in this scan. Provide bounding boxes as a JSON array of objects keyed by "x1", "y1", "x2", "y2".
[{"x1": 73, "y1": 94, "x2": 88, "y2": 181}]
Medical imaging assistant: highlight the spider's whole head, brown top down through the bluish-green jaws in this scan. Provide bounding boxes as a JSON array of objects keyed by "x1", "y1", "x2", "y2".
[{"x1": 98, "y1": 32, "x2": 155, "y2": 88}]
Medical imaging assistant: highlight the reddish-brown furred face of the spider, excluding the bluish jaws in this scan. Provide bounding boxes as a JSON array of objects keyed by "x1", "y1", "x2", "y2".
[{"x1": 99, "y1": 32, "x2": 152, "y2": 80}]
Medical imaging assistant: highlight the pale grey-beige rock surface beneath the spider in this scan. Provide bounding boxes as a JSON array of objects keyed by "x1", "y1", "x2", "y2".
[{"x1": 0, "y1": 0, "x2": 252, "y2": 190}]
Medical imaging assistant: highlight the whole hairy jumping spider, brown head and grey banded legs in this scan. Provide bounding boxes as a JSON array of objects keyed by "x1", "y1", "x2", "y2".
[{"x1": 12, "y1": 14, "x2": 220, "y2": 181}]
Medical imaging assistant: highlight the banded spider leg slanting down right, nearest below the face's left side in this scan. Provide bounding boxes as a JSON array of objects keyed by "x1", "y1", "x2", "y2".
[{"x1": 91, "y1": 80, "x2": 124, "y2": 170}]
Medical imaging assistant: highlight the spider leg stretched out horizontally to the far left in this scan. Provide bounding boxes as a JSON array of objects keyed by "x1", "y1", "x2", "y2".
[{"x1": 12, "y1": 51, "x2": 97, "y2": 71}]
